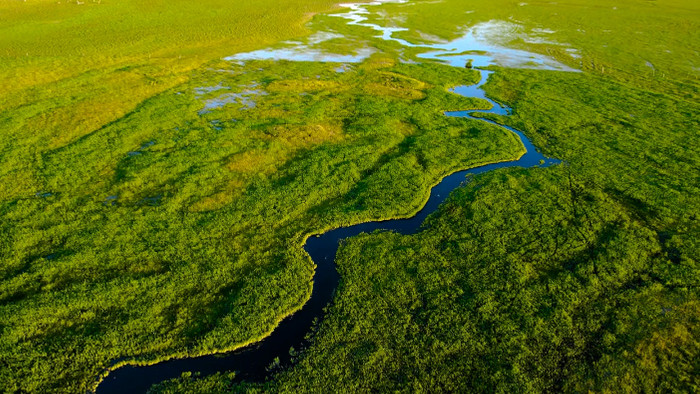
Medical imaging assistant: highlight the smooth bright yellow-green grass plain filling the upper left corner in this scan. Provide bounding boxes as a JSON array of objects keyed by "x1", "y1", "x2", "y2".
[{"x1": 0, "y1": 0, "x2": 352, "y2": 199}]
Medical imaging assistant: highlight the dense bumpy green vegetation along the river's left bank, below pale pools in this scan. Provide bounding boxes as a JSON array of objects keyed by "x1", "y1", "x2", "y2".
[{"x1": 0, "y1": 53, "x2": 522, "y2": 391}]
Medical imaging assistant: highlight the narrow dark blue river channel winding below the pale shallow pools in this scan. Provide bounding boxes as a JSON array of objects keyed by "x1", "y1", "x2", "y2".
[{"x1": 97, "y1": 65, "x2": 559, "y2": 394}]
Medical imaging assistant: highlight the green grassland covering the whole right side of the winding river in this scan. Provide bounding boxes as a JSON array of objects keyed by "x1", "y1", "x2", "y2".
[{"x1": 150, "y1": 1, "x2": 700, "y2": 393}]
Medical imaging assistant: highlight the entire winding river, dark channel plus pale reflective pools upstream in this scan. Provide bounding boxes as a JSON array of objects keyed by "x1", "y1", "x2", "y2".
[{"x1": 96, "y1": 3, "x2": 574, "y2": 393}]
